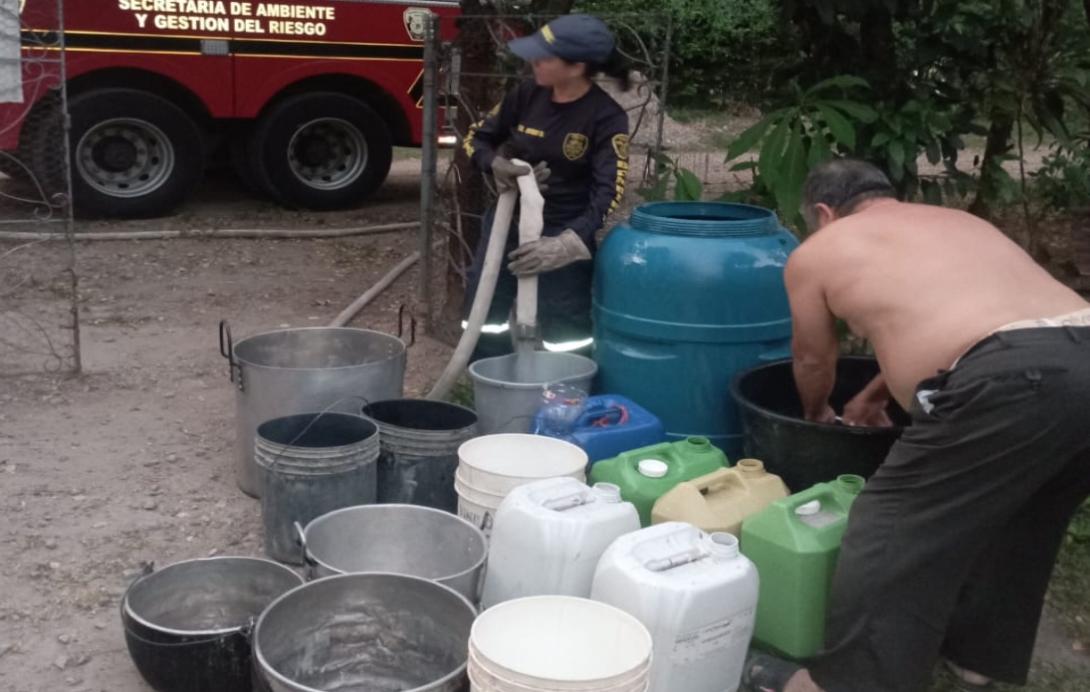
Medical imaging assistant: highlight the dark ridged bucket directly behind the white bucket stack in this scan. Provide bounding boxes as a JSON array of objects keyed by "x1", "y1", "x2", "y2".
[{"x1": 363, "y1": 399, "x2": 477, "y2": 512}]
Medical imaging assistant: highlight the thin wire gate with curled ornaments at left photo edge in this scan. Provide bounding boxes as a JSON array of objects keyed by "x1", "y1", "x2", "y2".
[{"x1": 0, "y1": 0, "x2": 81, "y2": 376}]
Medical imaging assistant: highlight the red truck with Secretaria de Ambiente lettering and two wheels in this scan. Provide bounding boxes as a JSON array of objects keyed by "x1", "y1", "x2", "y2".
[{"x1": 0, "y1": 0, "x2": 458, "y2": 217}]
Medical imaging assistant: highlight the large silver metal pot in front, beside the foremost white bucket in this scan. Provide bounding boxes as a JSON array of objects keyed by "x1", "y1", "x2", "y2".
[{"x1": 254, "y1": 573, "x2": 476, "y2": 692}]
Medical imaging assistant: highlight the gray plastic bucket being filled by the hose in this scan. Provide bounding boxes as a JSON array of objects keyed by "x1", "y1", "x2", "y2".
[{"x1": 470, "y1": 352, "x2": 598, "y2": 435}]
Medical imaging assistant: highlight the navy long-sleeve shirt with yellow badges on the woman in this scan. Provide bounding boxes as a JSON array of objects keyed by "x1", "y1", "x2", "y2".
[{"x1": 463, "y1": 80, "x2": 628, "y2": 251}]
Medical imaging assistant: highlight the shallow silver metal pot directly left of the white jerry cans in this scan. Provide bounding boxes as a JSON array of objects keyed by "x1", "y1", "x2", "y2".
[{"x1": 300, "y1": 505, "x2": 488, "y2": 603}]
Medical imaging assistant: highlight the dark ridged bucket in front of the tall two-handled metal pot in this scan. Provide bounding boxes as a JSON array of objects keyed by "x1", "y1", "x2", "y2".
[{"x1": 254, "y1": 413, "x2": 379, "y2": 564}]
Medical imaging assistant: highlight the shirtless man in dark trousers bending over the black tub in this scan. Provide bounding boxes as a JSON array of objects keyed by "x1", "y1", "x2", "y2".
[{"x1": 747, "y1": 160, "x2": 1090, "y2": 692}]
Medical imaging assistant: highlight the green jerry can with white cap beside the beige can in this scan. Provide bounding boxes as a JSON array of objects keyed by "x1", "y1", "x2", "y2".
[{"x1": 589, "y1": 437, "x2": 727, "y2": 527}]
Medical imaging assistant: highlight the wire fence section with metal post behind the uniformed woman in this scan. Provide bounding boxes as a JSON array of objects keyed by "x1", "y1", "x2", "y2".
[{"x1": 419, "y1": 14, "x2": 674, "y2": 331}]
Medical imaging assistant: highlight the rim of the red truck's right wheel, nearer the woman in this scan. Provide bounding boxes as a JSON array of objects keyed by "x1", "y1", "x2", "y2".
[{"x1": 288, "y1": 118, "x2": 367, "y2": 190}]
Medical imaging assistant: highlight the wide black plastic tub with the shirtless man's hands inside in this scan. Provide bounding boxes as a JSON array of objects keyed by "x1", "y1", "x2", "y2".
[{"x1": 730, "y1": 356, "x2": 909, "y2": 493}]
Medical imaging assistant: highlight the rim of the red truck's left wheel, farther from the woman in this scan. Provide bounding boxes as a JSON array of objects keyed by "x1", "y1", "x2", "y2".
[{"x1": 75, "y1": 118, "x2": 174, "y2": 198}]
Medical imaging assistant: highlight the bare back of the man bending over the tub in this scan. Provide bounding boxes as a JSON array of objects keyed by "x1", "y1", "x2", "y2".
[{"x1": 787, "y1": 198, "x2": 1090, "y2": 408}]
